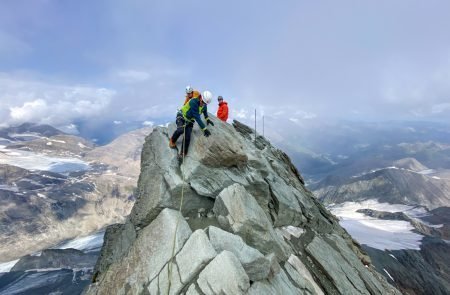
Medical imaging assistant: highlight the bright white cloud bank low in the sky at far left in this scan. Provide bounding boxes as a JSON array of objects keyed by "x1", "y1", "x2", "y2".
[{"x1": 0, "y1": 75, "x2": 116, "y2": 126}]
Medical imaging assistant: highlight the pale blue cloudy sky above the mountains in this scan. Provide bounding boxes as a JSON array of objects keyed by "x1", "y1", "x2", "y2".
[{"x1": 0, "y1": 0, "x2": 450, "y2": 132}]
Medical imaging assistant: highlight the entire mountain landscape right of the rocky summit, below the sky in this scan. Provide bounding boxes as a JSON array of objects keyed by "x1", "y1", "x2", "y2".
[{"x1": 282, "y1": 122, "x2": 450, "y2": 294}]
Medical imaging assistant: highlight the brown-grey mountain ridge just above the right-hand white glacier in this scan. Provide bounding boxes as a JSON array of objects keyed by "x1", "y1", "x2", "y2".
[{"x1": 310, "y1": 160, "x2": 450, "y2": 209}]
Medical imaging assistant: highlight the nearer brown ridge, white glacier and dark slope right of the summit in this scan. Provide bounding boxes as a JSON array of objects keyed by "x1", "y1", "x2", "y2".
[{"x1": 310, "y1": 159, "x2": 450, "y2": 294}]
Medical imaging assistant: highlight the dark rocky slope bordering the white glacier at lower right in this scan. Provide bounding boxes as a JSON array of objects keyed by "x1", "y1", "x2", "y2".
[{"x1": 358, "y1": 207, "x2": 450, "y2": 294}]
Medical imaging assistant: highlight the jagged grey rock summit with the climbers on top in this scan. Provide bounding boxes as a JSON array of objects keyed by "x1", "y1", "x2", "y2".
[{"x1": 86, "y1": 119, "x2": 400, "y2": 294}]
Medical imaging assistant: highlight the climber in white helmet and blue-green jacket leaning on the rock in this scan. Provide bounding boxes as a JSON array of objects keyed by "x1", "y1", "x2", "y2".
[{"x1": 169, "y1": 91, "x2": 214, "y2": 156}]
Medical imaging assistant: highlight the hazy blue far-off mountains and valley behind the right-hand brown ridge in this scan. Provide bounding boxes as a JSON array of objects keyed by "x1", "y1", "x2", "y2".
[{"x1": 267, "y1": 121, "x2": 450, "y2": 183}]
